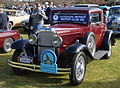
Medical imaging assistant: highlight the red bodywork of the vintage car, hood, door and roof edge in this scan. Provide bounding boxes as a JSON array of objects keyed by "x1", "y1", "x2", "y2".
[{"x1": 52, "y1": 7, "x2": 107, "y2": 48}]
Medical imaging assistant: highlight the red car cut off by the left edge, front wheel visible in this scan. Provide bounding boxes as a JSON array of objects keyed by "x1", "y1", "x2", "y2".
[{"x1": 0, "y1": 30, "x2": 20, "y2": 53}]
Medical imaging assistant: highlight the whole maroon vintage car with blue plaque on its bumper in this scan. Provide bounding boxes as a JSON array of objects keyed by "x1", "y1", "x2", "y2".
[{"x1": 8, "y1": 7, "x2": 115, "y2": 85}]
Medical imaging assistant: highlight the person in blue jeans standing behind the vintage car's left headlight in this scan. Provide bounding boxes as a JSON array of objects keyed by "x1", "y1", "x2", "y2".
[{"x1": 31, "y1": 3, "x2": 48, "y2": 33}]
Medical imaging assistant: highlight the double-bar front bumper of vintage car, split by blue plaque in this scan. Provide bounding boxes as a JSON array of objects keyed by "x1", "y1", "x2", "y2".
[{"x1": 8, "y1": 60, "x2": 70, "y2": 74}]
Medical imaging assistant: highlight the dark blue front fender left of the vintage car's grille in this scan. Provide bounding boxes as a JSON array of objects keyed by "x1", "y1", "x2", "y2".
[{"x1": 11, "y1": 39, "x2": 29, "y2": 50}]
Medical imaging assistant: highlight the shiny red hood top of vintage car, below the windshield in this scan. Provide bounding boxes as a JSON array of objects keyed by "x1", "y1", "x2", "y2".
[{"x1": 52, "y1": 23, "x2": 87, "y2": 36}]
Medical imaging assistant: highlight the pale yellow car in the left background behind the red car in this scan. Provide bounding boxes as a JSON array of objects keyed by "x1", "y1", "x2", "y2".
[{"x1": 4, "y1": 10, "x2": 30, "y2": 30}]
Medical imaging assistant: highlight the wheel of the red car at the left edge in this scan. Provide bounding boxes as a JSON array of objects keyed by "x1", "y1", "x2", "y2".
[{"x1": 2, "y1": 38, "x2": 13, "y2": 53}]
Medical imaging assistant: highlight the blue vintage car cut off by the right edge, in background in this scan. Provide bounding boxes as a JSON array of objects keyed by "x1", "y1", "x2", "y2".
[{"x1": 107, "y1": 5, "x2": 120, "y2": 31}]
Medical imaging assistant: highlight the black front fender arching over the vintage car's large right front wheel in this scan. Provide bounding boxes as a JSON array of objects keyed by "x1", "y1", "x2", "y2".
[{"x1": 58, "y1": 44, "x2": 93, "y2": 67}]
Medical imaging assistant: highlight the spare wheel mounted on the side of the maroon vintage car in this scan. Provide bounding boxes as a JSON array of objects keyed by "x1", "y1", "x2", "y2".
[{"x1": 83, "y1": 32, "x2": 96, "y2": 57}]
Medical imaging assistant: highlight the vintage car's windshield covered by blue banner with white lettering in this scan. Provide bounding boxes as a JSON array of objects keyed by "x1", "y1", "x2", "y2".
[{"x1": 52, "y1": 12, "x2": 89, "y2": 25}]
